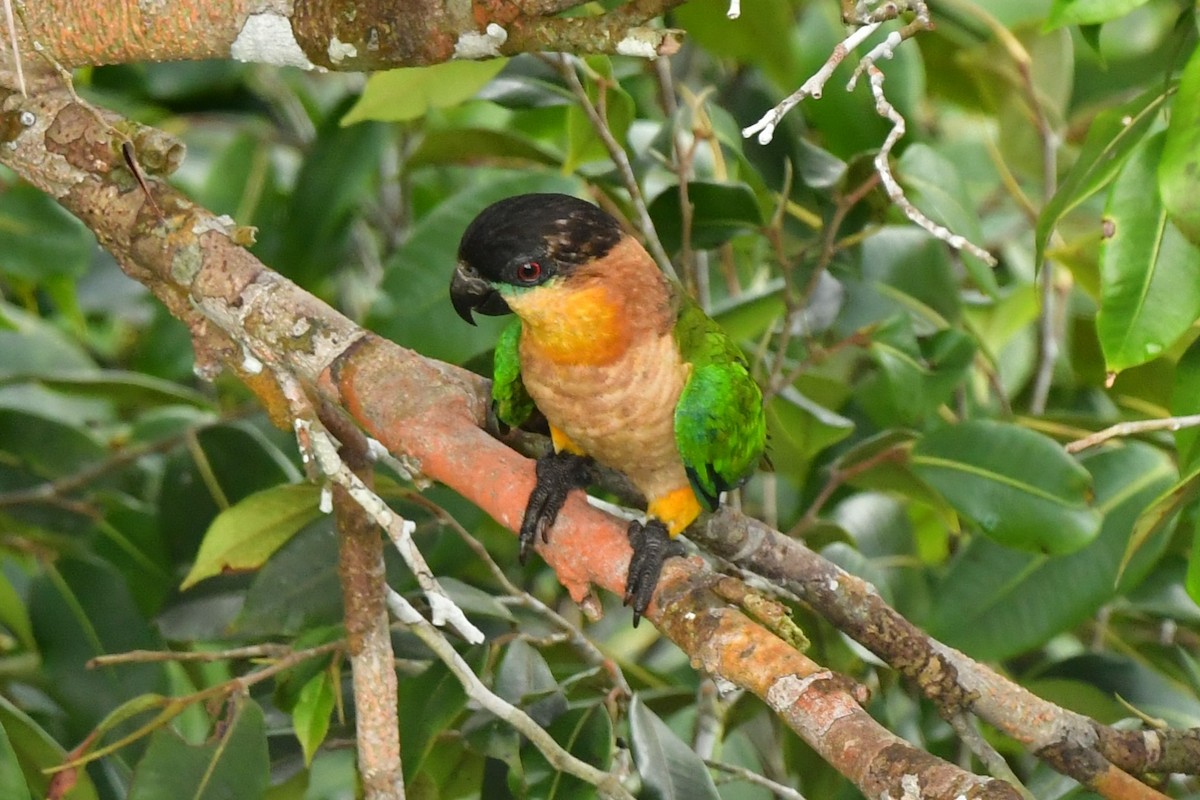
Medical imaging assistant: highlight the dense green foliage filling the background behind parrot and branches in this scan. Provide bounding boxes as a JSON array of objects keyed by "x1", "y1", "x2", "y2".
[{"x1": 0, "y1": 0, "x2": 1200, "y2": 800}]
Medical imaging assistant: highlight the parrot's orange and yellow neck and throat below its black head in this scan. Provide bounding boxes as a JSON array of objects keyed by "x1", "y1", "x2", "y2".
[{"x1": 510, "y1": 236, "x2": 673, "y2": 365}]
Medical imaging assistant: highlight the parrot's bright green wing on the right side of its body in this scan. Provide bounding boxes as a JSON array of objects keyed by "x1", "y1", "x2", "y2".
[{"x1": 674, "y1": 289, "x2": 767, "y2": 511}]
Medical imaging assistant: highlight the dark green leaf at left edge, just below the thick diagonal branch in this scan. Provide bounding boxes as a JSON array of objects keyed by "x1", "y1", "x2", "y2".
[{"x1": 0, "y1": 185, "x2": 96, "y2": 282}]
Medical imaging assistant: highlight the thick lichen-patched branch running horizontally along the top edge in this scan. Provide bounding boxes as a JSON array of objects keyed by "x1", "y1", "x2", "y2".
[{"x1": 0, "y1": 0, "x2": 682, "y2": 71}]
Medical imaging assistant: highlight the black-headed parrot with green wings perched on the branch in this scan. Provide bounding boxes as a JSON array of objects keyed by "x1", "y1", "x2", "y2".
[{"x1": 450, "y1": 193, "x2": 767, "y2": 626}]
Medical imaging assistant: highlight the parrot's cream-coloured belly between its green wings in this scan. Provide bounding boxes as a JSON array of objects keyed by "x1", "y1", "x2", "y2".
[{"x1": 522, "y1": 328, "x2": 688, "y2": 499}]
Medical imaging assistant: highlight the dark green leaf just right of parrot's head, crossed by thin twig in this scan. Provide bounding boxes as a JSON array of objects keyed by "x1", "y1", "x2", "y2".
[{"x1": 649, "y1": 181, "x2": 763, "y2": 253}]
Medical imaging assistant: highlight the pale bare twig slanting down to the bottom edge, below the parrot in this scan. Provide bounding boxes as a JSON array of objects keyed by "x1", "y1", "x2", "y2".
[{"x1": 388, "y1": 589, "x2": 634, "y2": 800}]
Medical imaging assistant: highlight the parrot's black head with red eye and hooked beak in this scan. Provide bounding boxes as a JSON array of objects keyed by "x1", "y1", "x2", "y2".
[{"x1": 450, "y1": 194, "x2": 622, "y2": 324}]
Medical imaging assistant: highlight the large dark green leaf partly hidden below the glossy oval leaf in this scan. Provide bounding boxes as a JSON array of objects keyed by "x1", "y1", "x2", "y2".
[{"x1": 923, "y1": 444, "x2": 1176, "y2": 661}]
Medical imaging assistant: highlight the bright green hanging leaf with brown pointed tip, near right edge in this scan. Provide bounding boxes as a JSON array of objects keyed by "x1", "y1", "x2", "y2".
[{"x1": 1096, "y1": 133, "x2": 1200, "y2": 372}]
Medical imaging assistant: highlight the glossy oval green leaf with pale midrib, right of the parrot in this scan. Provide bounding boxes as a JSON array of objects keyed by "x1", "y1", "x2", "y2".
[{"x1": 912, "y1": 421, "x2": 1100, "y2": 553}]
